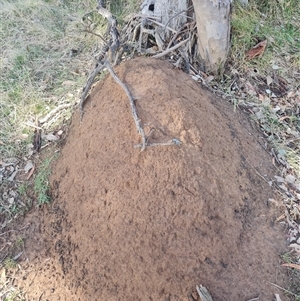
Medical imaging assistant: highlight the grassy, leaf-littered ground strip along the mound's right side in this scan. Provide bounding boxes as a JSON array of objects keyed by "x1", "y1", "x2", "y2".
[{"x1": 229, "y1": 0, "x2": 300, "y2": 300}]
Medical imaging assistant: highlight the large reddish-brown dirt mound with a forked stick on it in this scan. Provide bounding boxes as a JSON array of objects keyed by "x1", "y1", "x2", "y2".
[{"x1": 12, "y1": 58, "x2": 287, "y2": 301}]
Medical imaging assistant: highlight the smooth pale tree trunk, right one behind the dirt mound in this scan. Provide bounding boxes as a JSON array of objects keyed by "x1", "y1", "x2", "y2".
[{"x1": 193, "y1": 0, "x2": 231, "y2": 71}]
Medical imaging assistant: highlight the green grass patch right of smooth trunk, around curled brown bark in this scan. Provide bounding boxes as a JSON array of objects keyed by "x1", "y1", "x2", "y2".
[{"x1": 231, "y1": 0, "x2": 300, "y2": 78}]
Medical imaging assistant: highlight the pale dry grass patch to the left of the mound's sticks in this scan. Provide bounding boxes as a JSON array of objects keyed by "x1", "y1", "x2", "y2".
[{"x1": 0, "y1": 0, "x2": 100, "y2": 158}]
